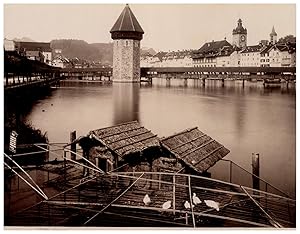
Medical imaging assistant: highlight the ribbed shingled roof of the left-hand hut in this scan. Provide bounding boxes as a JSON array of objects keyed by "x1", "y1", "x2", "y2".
[{"x1": 90, "y1": 121, "x2": 160, "y2": 157}]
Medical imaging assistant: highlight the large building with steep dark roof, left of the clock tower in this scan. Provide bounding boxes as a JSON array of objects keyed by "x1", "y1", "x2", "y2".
[{"x1": 192, "y1": 39, "x2": 232, "y2": 67}]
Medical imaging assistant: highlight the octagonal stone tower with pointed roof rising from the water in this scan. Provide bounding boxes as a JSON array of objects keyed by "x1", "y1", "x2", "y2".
[{"x1": 110, "y1": 4, "x2": 144, "y2": 82}]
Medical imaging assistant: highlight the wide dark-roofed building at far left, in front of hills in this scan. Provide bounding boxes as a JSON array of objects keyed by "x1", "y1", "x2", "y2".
[{"x1": 15, "y1": 41, "x2": 52, "y2": 65}]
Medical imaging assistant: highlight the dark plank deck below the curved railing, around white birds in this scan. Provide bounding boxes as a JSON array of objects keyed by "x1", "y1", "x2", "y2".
[{"x1": 5, "y1": 172, "x2": 296, "y2": 227}]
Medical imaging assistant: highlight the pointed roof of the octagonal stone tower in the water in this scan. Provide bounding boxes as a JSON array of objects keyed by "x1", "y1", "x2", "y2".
[{"x1": 110, "y1": 4, "x2": 144, "y2": 33}]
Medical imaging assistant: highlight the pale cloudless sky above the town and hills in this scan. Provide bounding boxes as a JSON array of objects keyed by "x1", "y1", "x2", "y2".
[{"x1": 3, "y1": 4, "x2": 296, "y2": 51}]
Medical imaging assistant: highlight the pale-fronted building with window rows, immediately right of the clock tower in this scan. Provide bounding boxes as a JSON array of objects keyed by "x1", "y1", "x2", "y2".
[{"x1": 240, "y1": 45, "x2": 262, "y2": 67}]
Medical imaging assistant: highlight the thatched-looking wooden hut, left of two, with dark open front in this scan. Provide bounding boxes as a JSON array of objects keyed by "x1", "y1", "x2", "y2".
[{"x1": 79, "y1": 121, "x2": 160, "y2": 172}]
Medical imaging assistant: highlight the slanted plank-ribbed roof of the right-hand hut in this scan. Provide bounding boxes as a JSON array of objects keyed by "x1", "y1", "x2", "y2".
[{"x1": 161, "y1": 127, "x2": 230, "y2": 173}]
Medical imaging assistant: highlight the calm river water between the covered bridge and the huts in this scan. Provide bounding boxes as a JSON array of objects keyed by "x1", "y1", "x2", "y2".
[{"x1": 25, "y1": 79, "x2": 296, "y2": 197}]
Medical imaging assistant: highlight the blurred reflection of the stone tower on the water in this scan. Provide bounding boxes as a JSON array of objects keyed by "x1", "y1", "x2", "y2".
[{"x1": 113, "y1": 83, "x2": 140, "y2": 124}]
